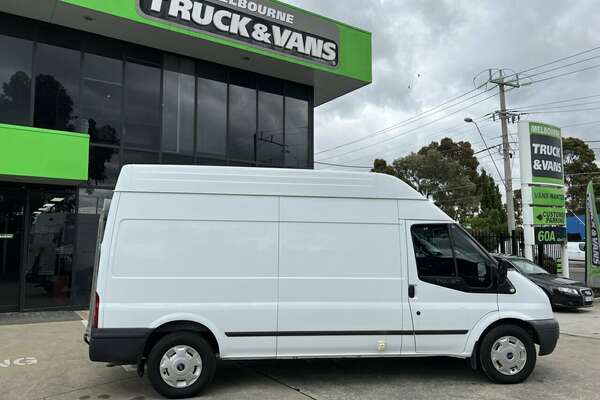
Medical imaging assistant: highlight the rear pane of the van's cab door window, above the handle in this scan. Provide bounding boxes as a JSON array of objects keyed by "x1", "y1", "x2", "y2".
[{"x1": 412, "y1": 225, "x2": 456, "y2": 278}]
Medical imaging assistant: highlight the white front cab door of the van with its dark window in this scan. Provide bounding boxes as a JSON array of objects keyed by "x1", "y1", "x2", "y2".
[{"x1": 406, "y1": 221, "x2": 498, "y2": 354}]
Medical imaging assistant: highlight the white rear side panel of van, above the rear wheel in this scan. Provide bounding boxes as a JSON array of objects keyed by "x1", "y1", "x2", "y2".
[{"x1": 102, "y1": 192, "x2": 279, "y2": 358}]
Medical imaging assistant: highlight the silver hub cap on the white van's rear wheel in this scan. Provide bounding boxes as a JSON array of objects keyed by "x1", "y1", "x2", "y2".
[{"x1": 160, "y1": 345, "x2": 202, "y2": 389}]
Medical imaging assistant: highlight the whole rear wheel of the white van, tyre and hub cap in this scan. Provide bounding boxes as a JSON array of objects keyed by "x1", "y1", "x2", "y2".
[{"x1": 148, "y1": 332, "x2": 216, "y2": 399}]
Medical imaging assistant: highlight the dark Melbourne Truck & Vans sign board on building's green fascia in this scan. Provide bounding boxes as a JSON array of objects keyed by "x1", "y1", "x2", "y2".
[{"x1": 134, "y1": 0, "x2": 340, "y2": 67}]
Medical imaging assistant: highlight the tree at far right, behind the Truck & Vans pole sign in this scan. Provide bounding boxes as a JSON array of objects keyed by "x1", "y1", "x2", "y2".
[{"x1": 563, "y1": 138, "x2": 600, "y2": 215}]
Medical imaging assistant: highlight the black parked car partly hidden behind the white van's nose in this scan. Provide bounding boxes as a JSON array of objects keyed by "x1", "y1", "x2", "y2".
[{"x1": 495, "y1": 256, "x2": 594, "y2": 309}]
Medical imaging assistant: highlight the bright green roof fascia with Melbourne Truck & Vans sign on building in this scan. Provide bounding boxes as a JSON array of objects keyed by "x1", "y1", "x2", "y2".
[{"x1": 60, "y1": 0, "x2": 372, "y2": 83}]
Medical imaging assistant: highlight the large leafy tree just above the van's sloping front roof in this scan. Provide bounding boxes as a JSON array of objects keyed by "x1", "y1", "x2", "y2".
[{"x1": 394, "y1": 149, "x2": 479, "y2": 220}]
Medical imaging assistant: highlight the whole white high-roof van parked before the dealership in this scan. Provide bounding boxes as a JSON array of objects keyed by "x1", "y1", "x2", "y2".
[{"x1": 86, "y1": 166, "x2": 559, "y2": 398}]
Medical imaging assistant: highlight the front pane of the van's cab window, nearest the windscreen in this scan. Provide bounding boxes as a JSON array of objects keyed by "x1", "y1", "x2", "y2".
[{"x1": 451, "y1": 226, "x2": 492, "y2": 288}]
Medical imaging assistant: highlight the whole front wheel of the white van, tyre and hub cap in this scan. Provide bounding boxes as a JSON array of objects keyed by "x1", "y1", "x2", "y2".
[{"x1": 479, "y1": 325, "x2": 537, "y2": 384}]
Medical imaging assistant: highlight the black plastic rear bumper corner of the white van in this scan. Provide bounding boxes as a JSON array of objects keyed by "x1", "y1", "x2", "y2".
[{"x1": 85, "y1": 328, "x2": 151, "y2": 365}]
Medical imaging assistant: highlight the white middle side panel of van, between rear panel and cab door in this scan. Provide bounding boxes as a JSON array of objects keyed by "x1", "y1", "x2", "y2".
[{"x1": 277, "y1": 197, "x2": 404, "y2": 358}]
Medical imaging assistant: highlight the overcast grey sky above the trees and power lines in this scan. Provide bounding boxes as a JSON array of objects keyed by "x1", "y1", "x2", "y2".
[{"x1": 289, "y1": 0, "x2": 600, "y2": 185}]
